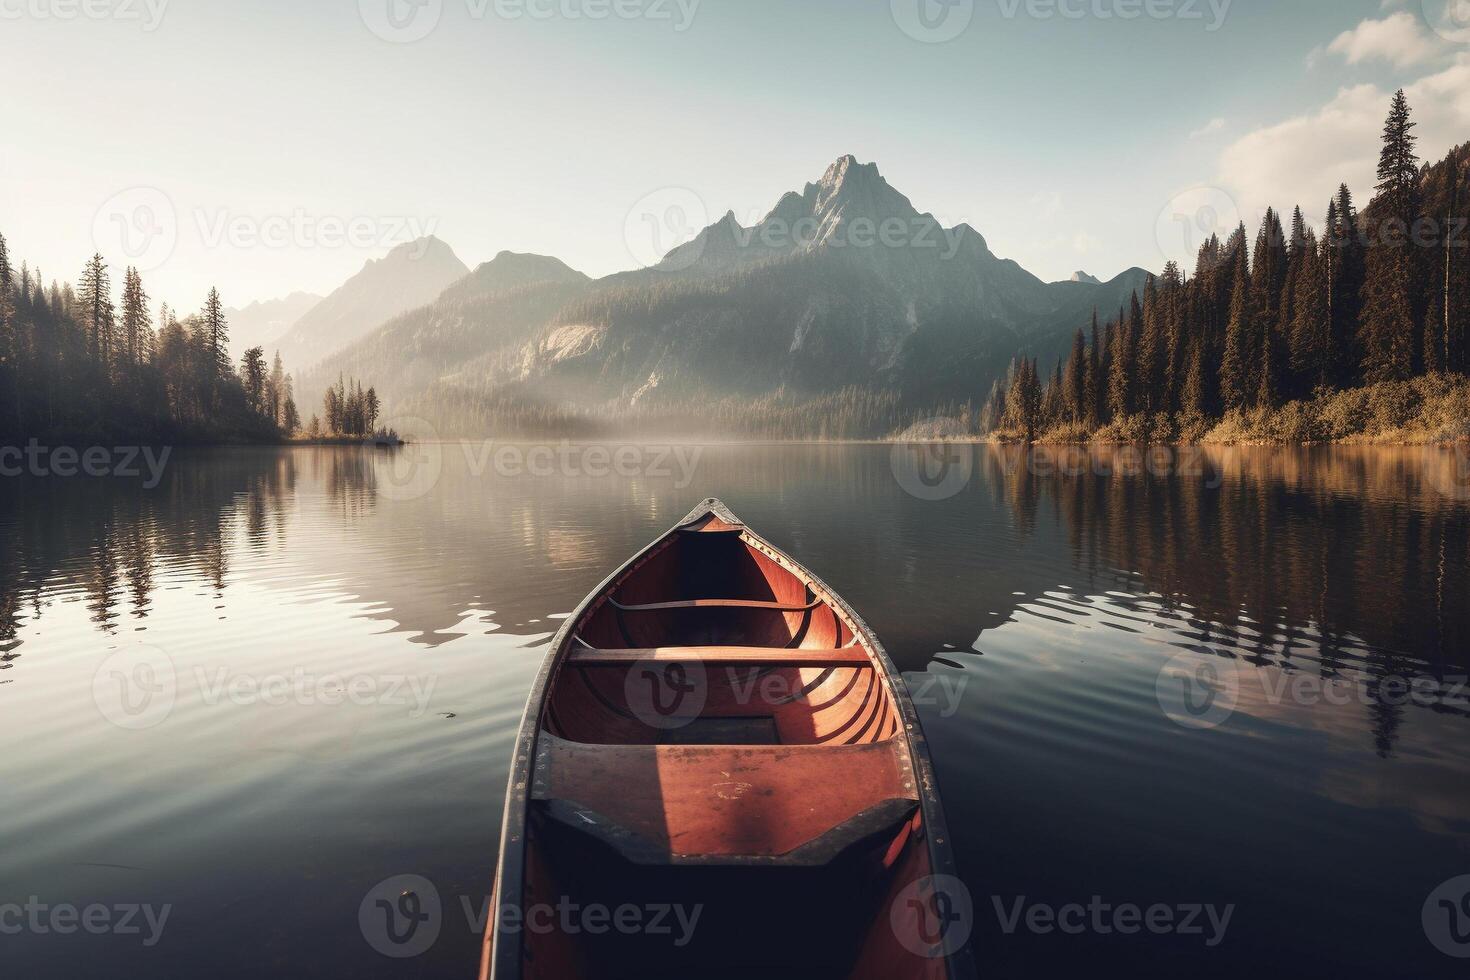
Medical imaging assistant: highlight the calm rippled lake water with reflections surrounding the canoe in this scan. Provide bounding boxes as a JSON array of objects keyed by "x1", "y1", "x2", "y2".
[{"x1": 0, "y1": 445, "x2": 1470, "y2": 977}]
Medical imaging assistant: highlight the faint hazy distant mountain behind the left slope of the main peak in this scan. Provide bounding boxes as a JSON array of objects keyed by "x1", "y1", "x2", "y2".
[{"x1": 271, "y1": 235, "x2": 469, "y2": 367}]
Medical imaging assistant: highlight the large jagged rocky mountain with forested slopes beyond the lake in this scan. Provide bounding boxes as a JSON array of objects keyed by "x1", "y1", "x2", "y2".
[{"x1": 304, "y1": 156, "x2": 1145, "y2": 435}]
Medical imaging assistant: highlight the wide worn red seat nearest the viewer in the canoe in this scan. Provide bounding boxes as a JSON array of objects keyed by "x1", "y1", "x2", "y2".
[{"x1": 532, "y1": 733, "x2": 919, "y2": 865}]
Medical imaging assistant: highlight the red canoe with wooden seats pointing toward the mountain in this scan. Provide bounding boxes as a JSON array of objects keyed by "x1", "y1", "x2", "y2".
[{"x1": 481, "y1": 498, "x2": 973, "y2": 980}]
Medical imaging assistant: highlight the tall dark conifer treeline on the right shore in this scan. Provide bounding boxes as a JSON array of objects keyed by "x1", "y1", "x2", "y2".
[{"x1": 983, "y1": 91, "x2": 1470, "y2": 441}]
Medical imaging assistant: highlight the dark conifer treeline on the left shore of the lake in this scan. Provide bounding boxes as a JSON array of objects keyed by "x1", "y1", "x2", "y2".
[{"x1": 0, "y1": 235, "x2": 300, "y2": 442}]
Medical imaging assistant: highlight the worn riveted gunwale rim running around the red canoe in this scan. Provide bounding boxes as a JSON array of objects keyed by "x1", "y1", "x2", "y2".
[{"x1": 481, "y1": 497, "x2": 975, "y2": 980}]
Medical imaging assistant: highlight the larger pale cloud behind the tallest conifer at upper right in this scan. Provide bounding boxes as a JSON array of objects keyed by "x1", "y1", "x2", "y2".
[{"x1": 1219, "y1": 54, "x2": 1470, "y2": 230}]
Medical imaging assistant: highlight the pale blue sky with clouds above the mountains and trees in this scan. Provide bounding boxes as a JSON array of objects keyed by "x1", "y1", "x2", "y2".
[{"x1": 0, "y1": 0, "x2": 1470, "y2": 310}]
